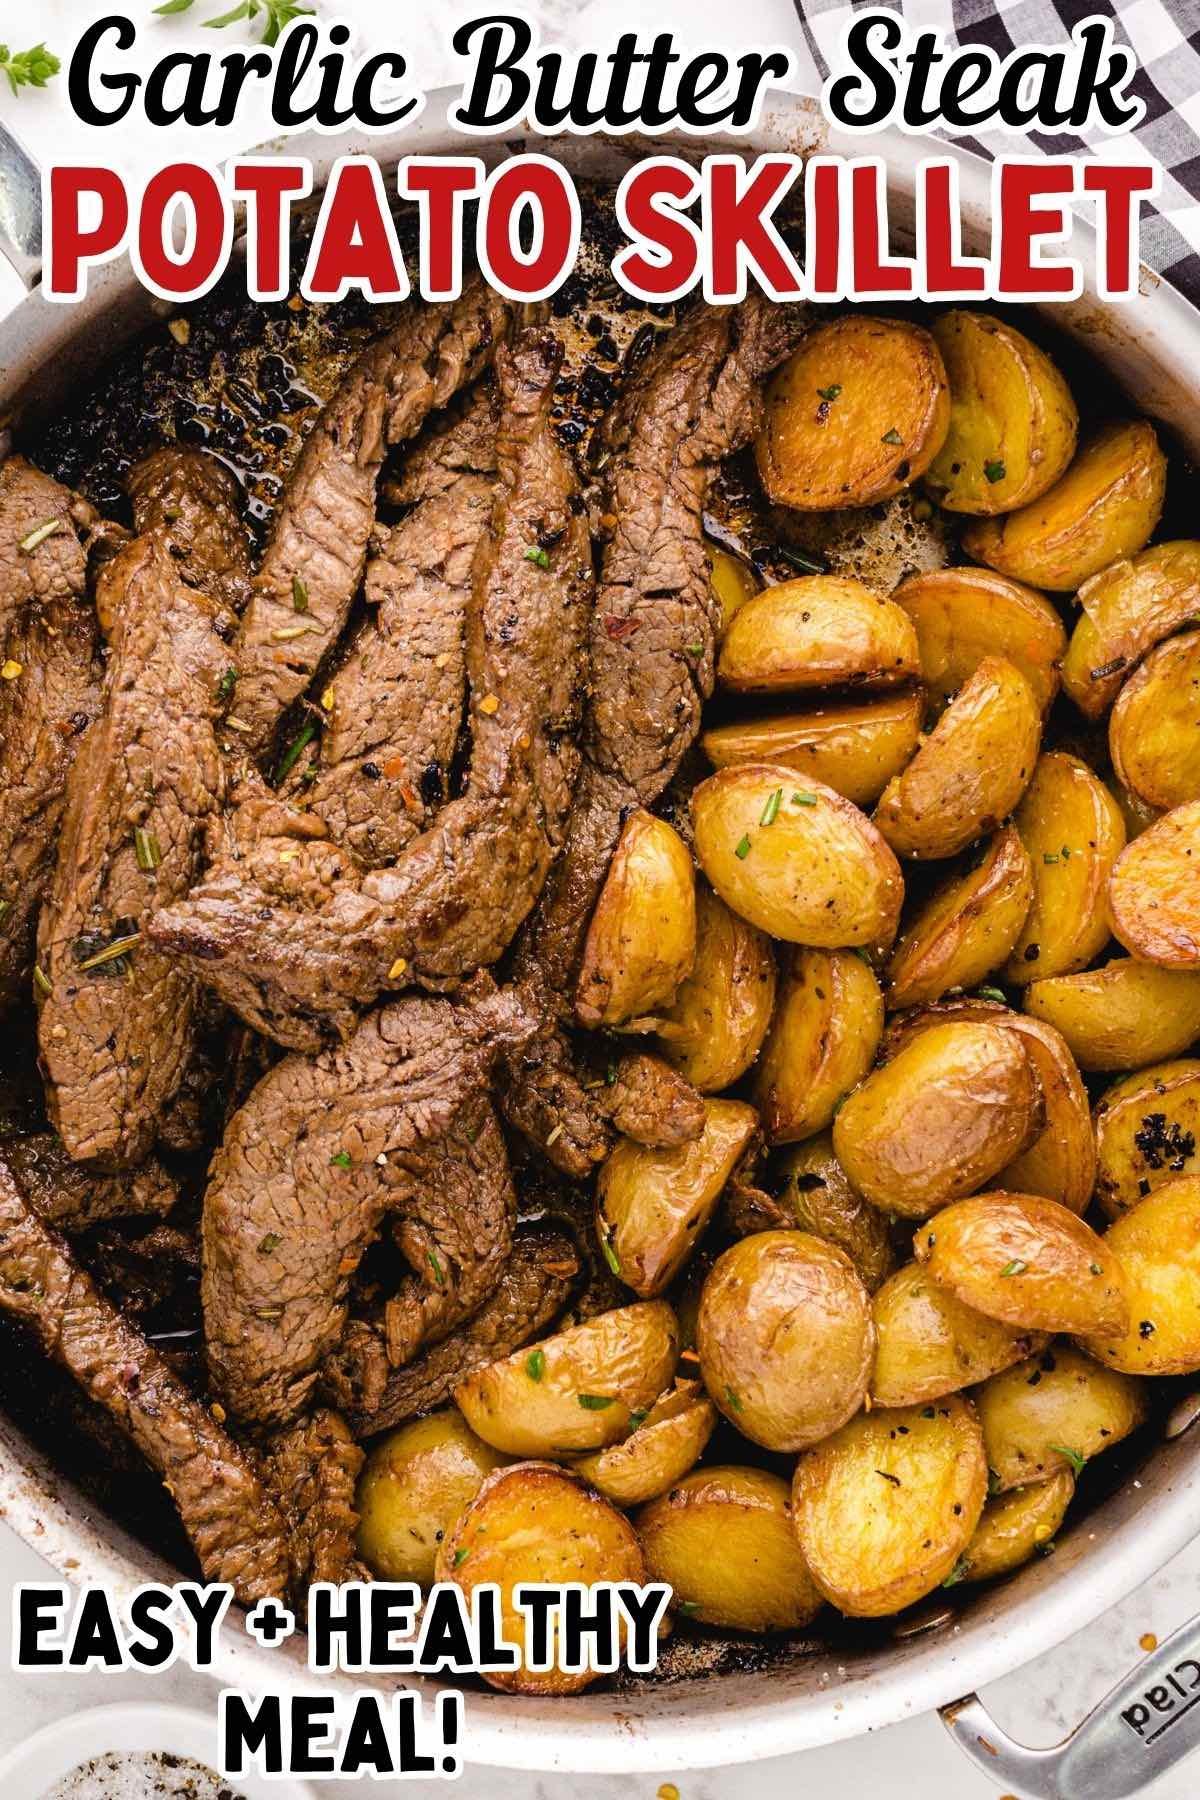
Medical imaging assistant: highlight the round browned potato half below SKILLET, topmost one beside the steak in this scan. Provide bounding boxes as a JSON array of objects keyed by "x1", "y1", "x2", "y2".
[{"x1": 756, "y1": 313, "x2": 950, "y2": 513}]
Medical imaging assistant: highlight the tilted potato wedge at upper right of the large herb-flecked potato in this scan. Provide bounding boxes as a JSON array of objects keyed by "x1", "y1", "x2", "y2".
[{"x1": 874, "y1": 657, "x2": 1042, "y2": 857}]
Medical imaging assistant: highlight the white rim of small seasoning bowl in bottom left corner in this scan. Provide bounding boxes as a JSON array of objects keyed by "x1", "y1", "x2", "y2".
[{"x1": 0, "y1": 1701, "x2": 315, "y2": 1800}]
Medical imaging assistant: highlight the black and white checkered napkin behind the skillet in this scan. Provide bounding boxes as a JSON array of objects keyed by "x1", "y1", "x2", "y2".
[{"x1": 793, "y1": 0, "x2": 1200, "y2": 306}]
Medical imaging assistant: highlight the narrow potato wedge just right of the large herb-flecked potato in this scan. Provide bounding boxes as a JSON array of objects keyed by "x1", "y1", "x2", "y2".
[{"x1": 887, "y1": 824, "x2": 1033, "y2": 1006}]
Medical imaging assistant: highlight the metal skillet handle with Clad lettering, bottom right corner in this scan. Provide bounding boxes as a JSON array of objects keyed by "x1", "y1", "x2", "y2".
[{"x1": 941, "y1": 1618, "x2": 1200, "y2": 1800}]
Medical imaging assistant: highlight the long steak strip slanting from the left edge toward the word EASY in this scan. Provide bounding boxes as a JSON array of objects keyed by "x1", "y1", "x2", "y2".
[{"x1": 0, "y1": 1157, "x2": 288, "y2": 1604}]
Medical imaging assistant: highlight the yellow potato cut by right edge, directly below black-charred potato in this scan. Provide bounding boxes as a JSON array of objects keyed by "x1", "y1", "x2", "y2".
[{"x1": 1079, "y1": 1175, "x2": 1200, "y2": 1375}]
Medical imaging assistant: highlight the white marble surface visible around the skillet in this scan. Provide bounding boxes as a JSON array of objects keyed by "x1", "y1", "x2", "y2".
[{"x1": 0, "y1": 0, "x2": 1200, "y2": 1800}]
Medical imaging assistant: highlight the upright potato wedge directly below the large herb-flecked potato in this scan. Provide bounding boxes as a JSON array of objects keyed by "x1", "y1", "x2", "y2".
[{"x1": 754, "y1": 949, "x2": 883, "y2": 1143}]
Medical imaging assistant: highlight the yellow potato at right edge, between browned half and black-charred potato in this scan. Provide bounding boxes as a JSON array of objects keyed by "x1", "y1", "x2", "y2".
[{"x1": 1025, "y1": 956, "x2": 1200, "y2": 1071}]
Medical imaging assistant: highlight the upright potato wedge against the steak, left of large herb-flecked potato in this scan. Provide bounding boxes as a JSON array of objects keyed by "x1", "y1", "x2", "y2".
[{"x1": 576, "y1": 812, "x2": 696, "y2": 1030}]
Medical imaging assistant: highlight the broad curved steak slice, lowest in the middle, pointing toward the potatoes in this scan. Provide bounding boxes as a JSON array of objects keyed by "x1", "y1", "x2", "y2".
[{"x1": 203, "y1": 983, "x2": 527, "y2": 1426}]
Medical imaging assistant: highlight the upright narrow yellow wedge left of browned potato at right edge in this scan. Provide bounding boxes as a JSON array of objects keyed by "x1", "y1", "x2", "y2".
[{"x1": 1004, "y1": 751, "x2": 1124, "y2": 986}]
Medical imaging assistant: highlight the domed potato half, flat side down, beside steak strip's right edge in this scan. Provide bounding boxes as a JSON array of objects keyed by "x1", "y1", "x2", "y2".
[{"x1": 716, "y1": 574, "x2": 921, "y2": 693}]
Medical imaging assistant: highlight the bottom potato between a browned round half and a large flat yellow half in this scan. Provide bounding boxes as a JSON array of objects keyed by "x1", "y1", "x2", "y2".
[{"x1": 635, "y1": 1465, "x2": 822, "y2": 1631}]
